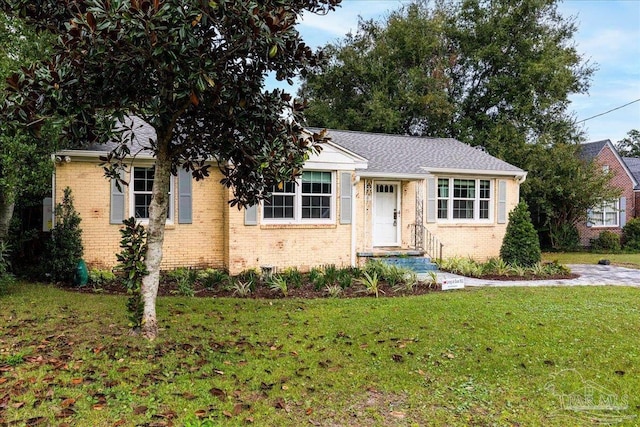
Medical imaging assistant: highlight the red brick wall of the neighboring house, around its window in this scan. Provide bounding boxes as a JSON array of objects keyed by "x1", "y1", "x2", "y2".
[{"x1": 578, "y1": 145, "x2": 640, "y2": 246}]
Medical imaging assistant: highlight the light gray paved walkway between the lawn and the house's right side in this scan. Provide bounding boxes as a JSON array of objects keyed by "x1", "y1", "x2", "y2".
[{"x1": 425, "y1": 264, "x2": 640, "y2": 287}]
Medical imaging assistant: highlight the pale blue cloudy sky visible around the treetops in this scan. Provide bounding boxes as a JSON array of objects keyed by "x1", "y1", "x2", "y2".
[{"x1": 270, "y1": 0, "x2": 640, "y2": 142}]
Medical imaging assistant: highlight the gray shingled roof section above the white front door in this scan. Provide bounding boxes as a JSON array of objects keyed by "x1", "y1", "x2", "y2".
[{"x1": 320, "y1": 129, "x2": 524, "y2": 175}]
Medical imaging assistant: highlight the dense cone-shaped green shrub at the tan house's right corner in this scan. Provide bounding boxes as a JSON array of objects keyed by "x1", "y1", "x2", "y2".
[{"x1": 500, "y1": 201, "x2": 542, "y2": 267}]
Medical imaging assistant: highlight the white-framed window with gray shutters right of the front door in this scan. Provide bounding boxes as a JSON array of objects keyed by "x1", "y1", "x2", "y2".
[{"x1": 438, "y1": 178, "x2": 492, "y2": 221}]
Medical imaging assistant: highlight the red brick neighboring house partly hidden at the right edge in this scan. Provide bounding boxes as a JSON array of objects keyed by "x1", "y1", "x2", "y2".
[{"x1": 577, "y1": 139, "x2": 640, "y2": 246}]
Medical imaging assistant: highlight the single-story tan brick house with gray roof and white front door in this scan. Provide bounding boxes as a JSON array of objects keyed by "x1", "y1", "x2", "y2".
[{"x1": 53, "y1": 125, "x2": 526, "y2": 274}]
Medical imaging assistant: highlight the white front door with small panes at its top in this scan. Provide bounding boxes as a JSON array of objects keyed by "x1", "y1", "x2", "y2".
[{"x1": 373, "y1": 182, "x2": 400, "y2": 246}]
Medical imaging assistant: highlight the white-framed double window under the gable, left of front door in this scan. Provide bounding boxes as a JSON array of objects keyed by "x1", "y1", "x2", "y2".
[{"x1": 262, "y1": 171, "x2": 335, "y2": 222}]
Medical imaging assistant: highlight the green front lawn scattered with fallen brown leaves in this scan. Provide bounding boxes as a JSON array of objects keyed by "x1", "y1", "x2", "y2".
[{"x1": 0, "y1": 285, "x2": 640, "y2": 426}]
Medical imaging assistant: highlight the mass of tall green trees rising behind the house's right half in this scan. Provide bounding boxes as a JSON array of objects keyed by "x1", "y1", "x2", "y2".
[{"x1": 299, "y1": 0, "x2": 610, "y2": 246}]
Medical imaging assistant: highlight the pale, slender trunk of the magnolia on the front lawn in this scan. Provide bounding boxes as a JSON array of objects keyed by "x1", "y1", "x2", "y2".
[{"x1": 141, "y1": 144, "x2": 171, "y2": 340}]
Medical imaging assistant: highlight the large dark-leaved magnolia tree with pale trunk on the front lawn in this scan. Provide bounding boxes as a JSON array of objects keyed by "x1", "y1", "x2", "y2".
[{"x1": 0, "y1": 0, "x2": 340, "y2": 339}]
